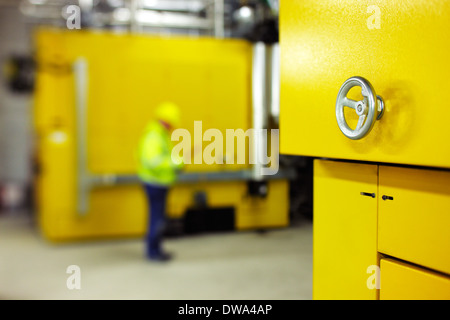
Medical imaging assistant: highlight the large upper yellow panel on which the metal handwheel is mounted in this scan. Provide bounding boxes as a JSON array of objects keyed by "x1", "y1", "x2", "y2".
[{"x1": 280, "y1": 0, "x2": 450, "y2": 167}]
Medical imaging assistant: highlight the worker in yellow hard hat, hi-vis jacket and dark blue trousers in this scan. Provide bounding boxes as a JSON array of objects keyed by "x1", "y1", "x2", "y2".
[{"x1": 138, "y1": 102, "x2": 183, "y2": 261}]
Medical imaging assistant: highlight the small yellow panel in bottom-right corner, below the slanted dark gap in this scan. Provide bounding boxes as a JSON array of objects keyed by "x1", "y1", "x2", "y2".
[{"x1": 380, "y1": 259, "x2": 450, "y2": 300}]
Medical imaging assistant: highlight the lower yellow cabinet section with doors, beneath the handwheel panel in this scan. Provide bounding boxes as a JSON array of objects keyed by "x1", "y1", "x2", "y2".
[{"x1": 313, "y1": 159, "x2": 450, "y2": 300}]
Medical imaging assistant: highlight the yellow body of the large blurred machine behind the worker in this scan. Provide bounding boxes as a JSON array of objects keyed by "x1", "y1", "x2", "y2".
[{"x1": 33, "y1": 29, "x2": 288, "y2": 240}]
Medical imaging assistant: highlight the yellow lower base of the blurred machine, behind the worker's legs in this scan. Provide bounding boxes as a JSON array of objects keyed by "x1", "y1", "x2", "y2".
[{"x1": 49, "y1": 180, "x2": 289, "y2": 240}]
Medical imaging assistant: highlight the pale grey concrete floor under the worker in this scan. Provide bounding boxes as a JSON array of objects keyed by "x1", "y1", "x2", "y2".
[{"x1": 0, "y1": 214, "x2": 312, "y2": 300}]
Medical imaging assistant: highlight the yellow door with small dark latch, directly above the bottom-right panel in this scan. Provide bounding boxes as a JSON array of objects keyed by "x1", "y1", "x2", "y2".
[{"x1": 378, "y1": 166, "x2": 450, "y2": 274}]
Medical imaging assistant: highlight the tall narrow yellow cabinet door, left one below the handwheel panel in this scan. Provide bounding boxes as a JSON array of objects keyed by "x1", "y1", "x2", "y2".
[{"x1": 313, "y1": 160, "x2": 378, "y2": 299}]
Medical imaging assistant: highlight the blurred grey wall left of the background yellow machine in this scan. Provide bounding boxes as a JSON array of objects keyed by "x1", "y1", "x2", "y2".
[{"x1": 0, "y1": 5, "x2": 33, "y2": 209}]
